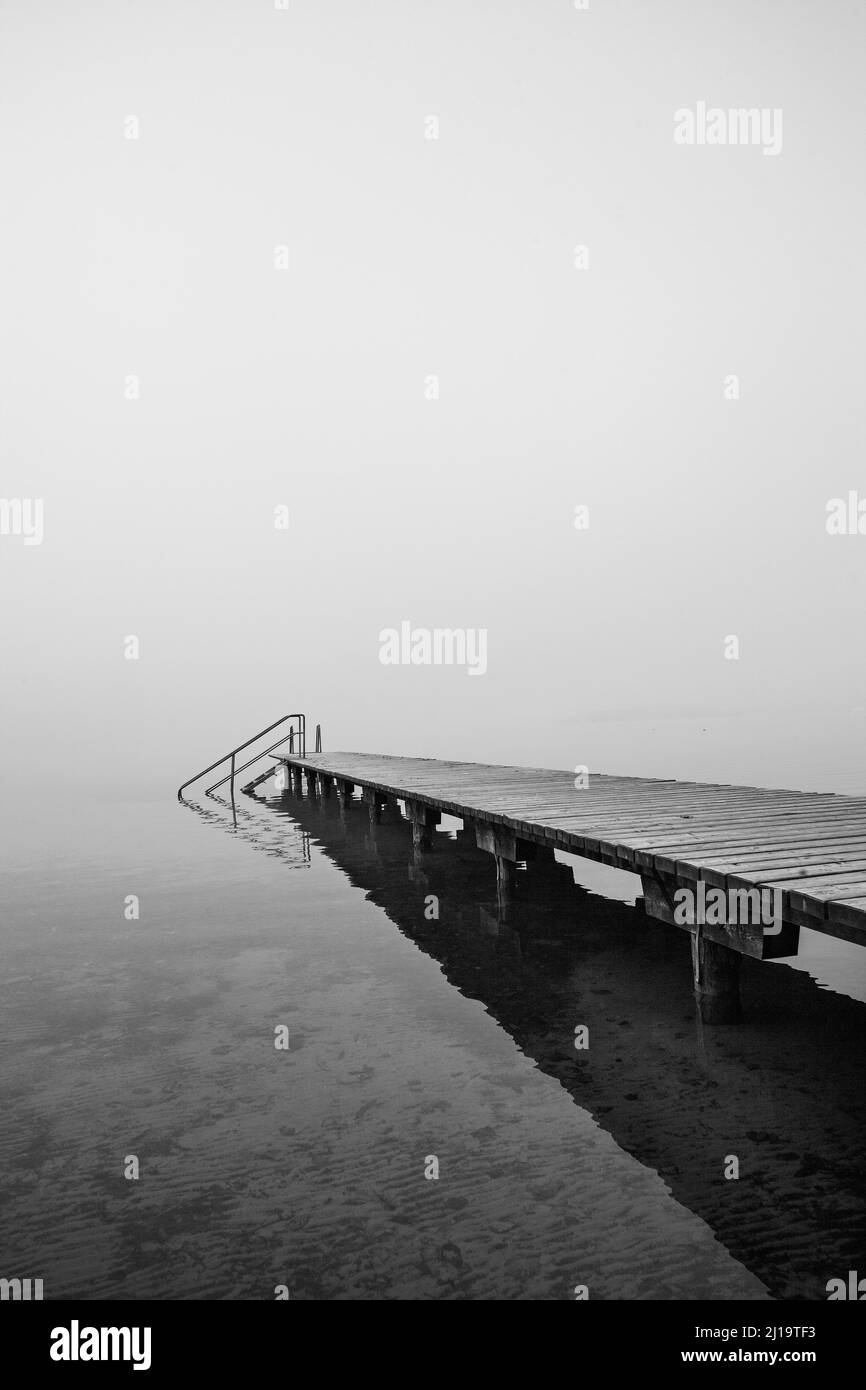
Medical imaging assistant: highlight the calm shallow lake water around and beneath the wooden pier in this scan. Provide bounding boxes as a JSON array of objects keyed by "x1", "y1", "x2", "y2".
[{"x1": 0, "y1": 784, "x2": 866, "y2": 1300}]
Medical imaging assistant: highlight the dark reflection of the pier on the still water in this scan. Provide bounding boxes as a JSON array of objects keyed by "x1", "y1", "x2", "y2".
[{"x1": 257, "y1": 781, "x2": 866, "y2": 1298}]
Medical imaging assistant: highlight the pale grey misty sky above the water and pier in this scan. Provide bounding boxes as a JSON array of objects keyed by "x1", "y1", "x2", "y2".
[{"x1": 0, "y1": 0, "x2": 866, "y2": 809}]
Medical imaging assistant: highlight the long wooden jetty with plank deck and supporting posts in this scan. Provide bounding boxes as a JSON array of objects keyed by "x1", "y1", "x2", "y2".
[{"x1": 261, "y1": 752, "x2": 866, "y2": 1022}]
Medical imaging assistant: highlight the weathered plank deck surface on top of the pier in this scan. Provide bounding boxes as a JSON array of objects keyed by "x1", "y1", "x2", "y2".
[{"x1": 271, "y1": 753, "x2": 866, "y2": 945}]
